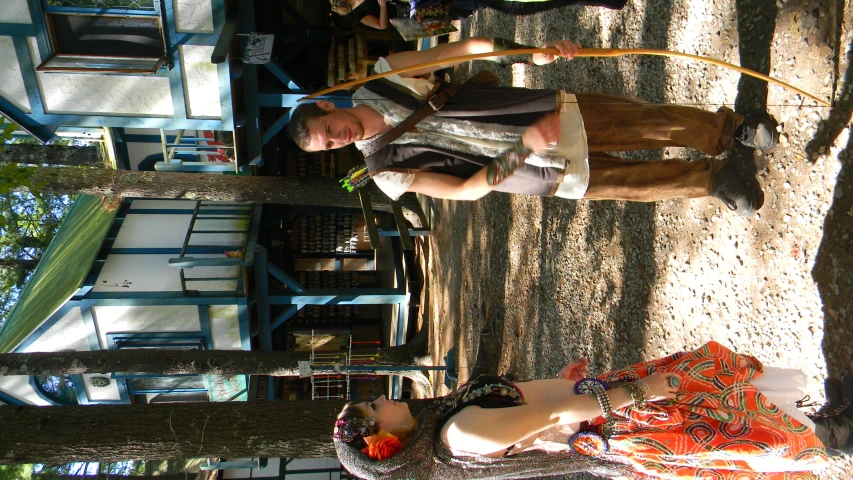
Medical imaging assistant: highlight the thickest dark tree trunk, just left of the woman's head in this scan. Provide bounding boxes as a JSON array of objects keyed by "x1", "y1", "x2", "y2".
[{"x1": 0, "y1": 400, "x2": 435, "y2": 465}]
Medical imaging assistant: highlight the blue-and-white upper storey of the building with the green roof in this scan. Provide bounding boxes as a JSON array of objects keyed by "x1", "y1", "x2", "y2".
[{"x1": 0, "y1": 195, "x2": 260, "y2": 405}]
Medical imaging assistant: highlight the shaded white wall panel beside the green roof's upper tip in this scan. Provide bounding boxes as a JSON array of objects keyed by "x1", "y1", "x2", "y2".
[{"x1": 113, "y1": 216, "x2": 192, "y2": 248}]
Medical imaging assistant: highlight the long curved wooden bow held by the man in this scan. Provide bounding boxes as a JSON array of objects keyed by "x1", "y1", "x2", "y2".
[{"x1": 299, "y1": 48, "x2": 831, "y2": 107}]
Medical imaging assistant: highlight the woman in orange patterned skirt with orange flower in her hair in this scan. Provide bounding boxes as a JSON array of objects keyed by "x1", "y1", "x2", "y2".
[{"x1": 334, "y1": 342, "x2": 840, "y2": 480}]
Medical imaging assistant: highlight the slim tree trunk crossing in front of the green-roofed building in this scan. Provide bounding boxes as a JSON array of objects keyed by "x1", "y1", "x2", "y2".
[{"x1": 0, "y1": 344, "x2": 440, "y2": 377}]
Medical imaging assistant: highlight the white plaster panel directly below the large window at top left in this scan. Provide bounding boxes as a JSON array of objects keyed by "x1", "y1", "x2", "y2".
[{"x1": 27, "y1": 37, "x2": 175, "y2": 117}]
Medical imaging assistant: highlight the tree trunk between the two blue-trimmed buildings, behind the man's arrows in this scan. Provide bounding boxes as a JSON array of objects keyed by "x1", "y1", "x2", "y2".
[{"x1": 16, "y1": 167, "x2": 420, "y2": 226}]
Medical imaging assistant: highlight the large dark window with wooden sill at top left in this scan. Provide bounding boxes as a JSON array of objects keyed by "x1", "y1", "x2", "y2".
[{"x1": 38, "y1": 0, "x2": 166, "y2": 73}]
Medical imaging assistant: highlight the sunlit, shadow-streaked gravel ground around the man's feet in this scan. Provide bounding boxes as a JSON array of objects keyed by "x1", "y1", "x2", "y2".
[{"x1": 410, "y1": 0, "x2": 853, "y2": 479}]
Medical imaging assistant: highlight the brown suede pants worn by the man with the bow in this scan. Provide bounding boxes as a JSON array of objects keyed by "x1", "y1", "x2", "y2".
[{"x1": 576, "y1": 94, "x2": 743, "y2": 202}]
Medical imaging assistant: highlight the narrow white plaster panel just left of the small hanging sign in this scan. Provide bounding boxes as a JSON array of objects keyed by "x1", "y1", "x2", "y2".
[{"x1": 180, "y1": 45, "x2": 222, "y2": 118}]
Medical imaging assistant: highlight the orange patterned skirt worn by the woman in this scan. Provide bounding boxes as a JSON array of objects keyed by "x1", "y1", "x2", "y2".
[{"x1": 599, "y1": 342, "x2": 828, "y2": 480}]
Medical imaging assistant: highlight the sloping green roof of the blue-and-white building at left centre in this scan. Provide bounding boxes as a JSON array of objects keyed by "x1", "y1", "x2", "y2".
[{"x1": 0, "y1": 195, "x2": 118, "y2": 353}]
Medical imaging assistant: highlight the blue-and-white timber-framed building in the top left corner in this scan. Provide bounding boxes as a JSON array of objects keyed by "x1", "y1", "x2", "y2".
[{"x1": 0, "y1": 0, "x2": 350, "y2": 172}]
